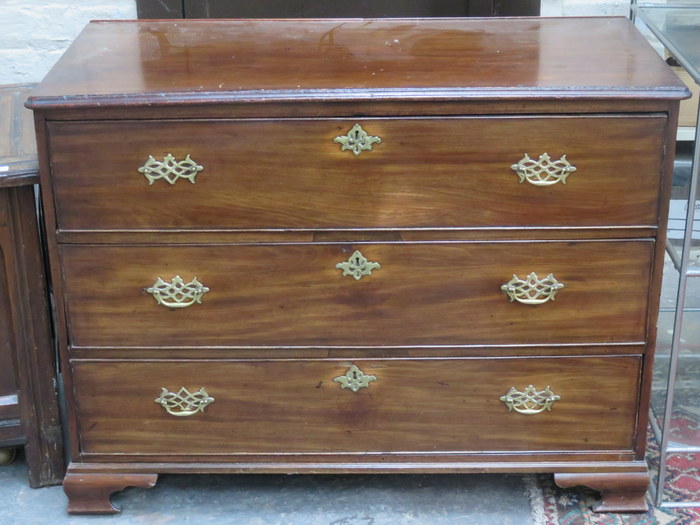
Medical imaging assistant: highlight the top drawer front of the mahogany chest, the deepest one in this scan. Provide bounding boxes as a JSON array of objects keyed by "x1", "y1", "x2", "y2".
[{"x1": 49, "y1": 116, "x2": 666, "y2": 230}]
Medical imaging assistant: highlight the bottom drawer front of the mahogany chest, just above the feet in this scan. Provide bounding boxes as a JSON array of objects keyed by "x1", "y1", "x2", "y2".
[{"x1": 73, "y1": 356, "x2": 640, "y2": 455}]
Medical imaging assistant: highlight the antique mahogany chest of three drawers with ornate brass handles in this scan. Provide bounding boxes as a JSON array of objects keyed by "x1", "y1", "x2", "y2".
[{"x1": 28, "y1": 18, "x2": 686, "y2": 513}]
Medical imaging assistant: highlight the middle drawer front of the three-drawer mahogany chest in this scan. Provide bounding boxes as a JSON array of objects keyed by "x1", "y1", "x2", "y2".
[{"x1": 61, "y1": 241, "x2": 654, "y2": 347}]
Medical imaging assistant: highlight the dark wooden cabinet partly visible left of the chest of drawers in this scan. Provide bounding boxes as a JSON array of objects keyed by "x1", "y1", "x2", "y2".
[{"x1": 0, "y1": 84, "x2": 65, "y2": 487}]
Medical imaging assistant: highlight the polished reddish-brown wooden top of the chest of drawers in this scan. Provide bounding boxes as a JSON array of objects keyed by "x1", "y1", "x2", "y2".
[{"x1": 29, "y1": 17, "x2": 688, "y2": 108}]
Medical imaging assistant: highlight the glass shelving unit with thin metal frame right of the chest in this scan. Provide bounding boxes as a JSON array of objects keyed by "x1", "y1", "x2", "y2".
[{"x1": 633, "y1": 3, "x2": 700, "y2": 507}]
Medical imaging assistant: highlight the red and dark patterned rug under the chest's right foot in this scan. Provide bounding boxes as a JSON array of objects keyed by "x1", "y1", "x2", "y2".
[{"x1": 525, "y1": 422, "x2": 700, "y2": 525}]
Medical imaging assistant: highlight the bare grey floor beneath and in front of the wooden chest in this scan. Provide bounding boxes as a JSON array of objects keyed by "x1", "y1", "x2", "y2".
[{"x1": 0, "y1": 448, "x2": 533, "y2": 525}]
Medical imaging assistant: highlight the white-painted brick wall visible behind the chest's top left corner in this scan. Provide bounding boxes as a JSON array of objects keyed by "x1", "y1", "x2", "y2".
[{"x1": 0, "y1": 0, "x2": 136, "y2": 84}]
